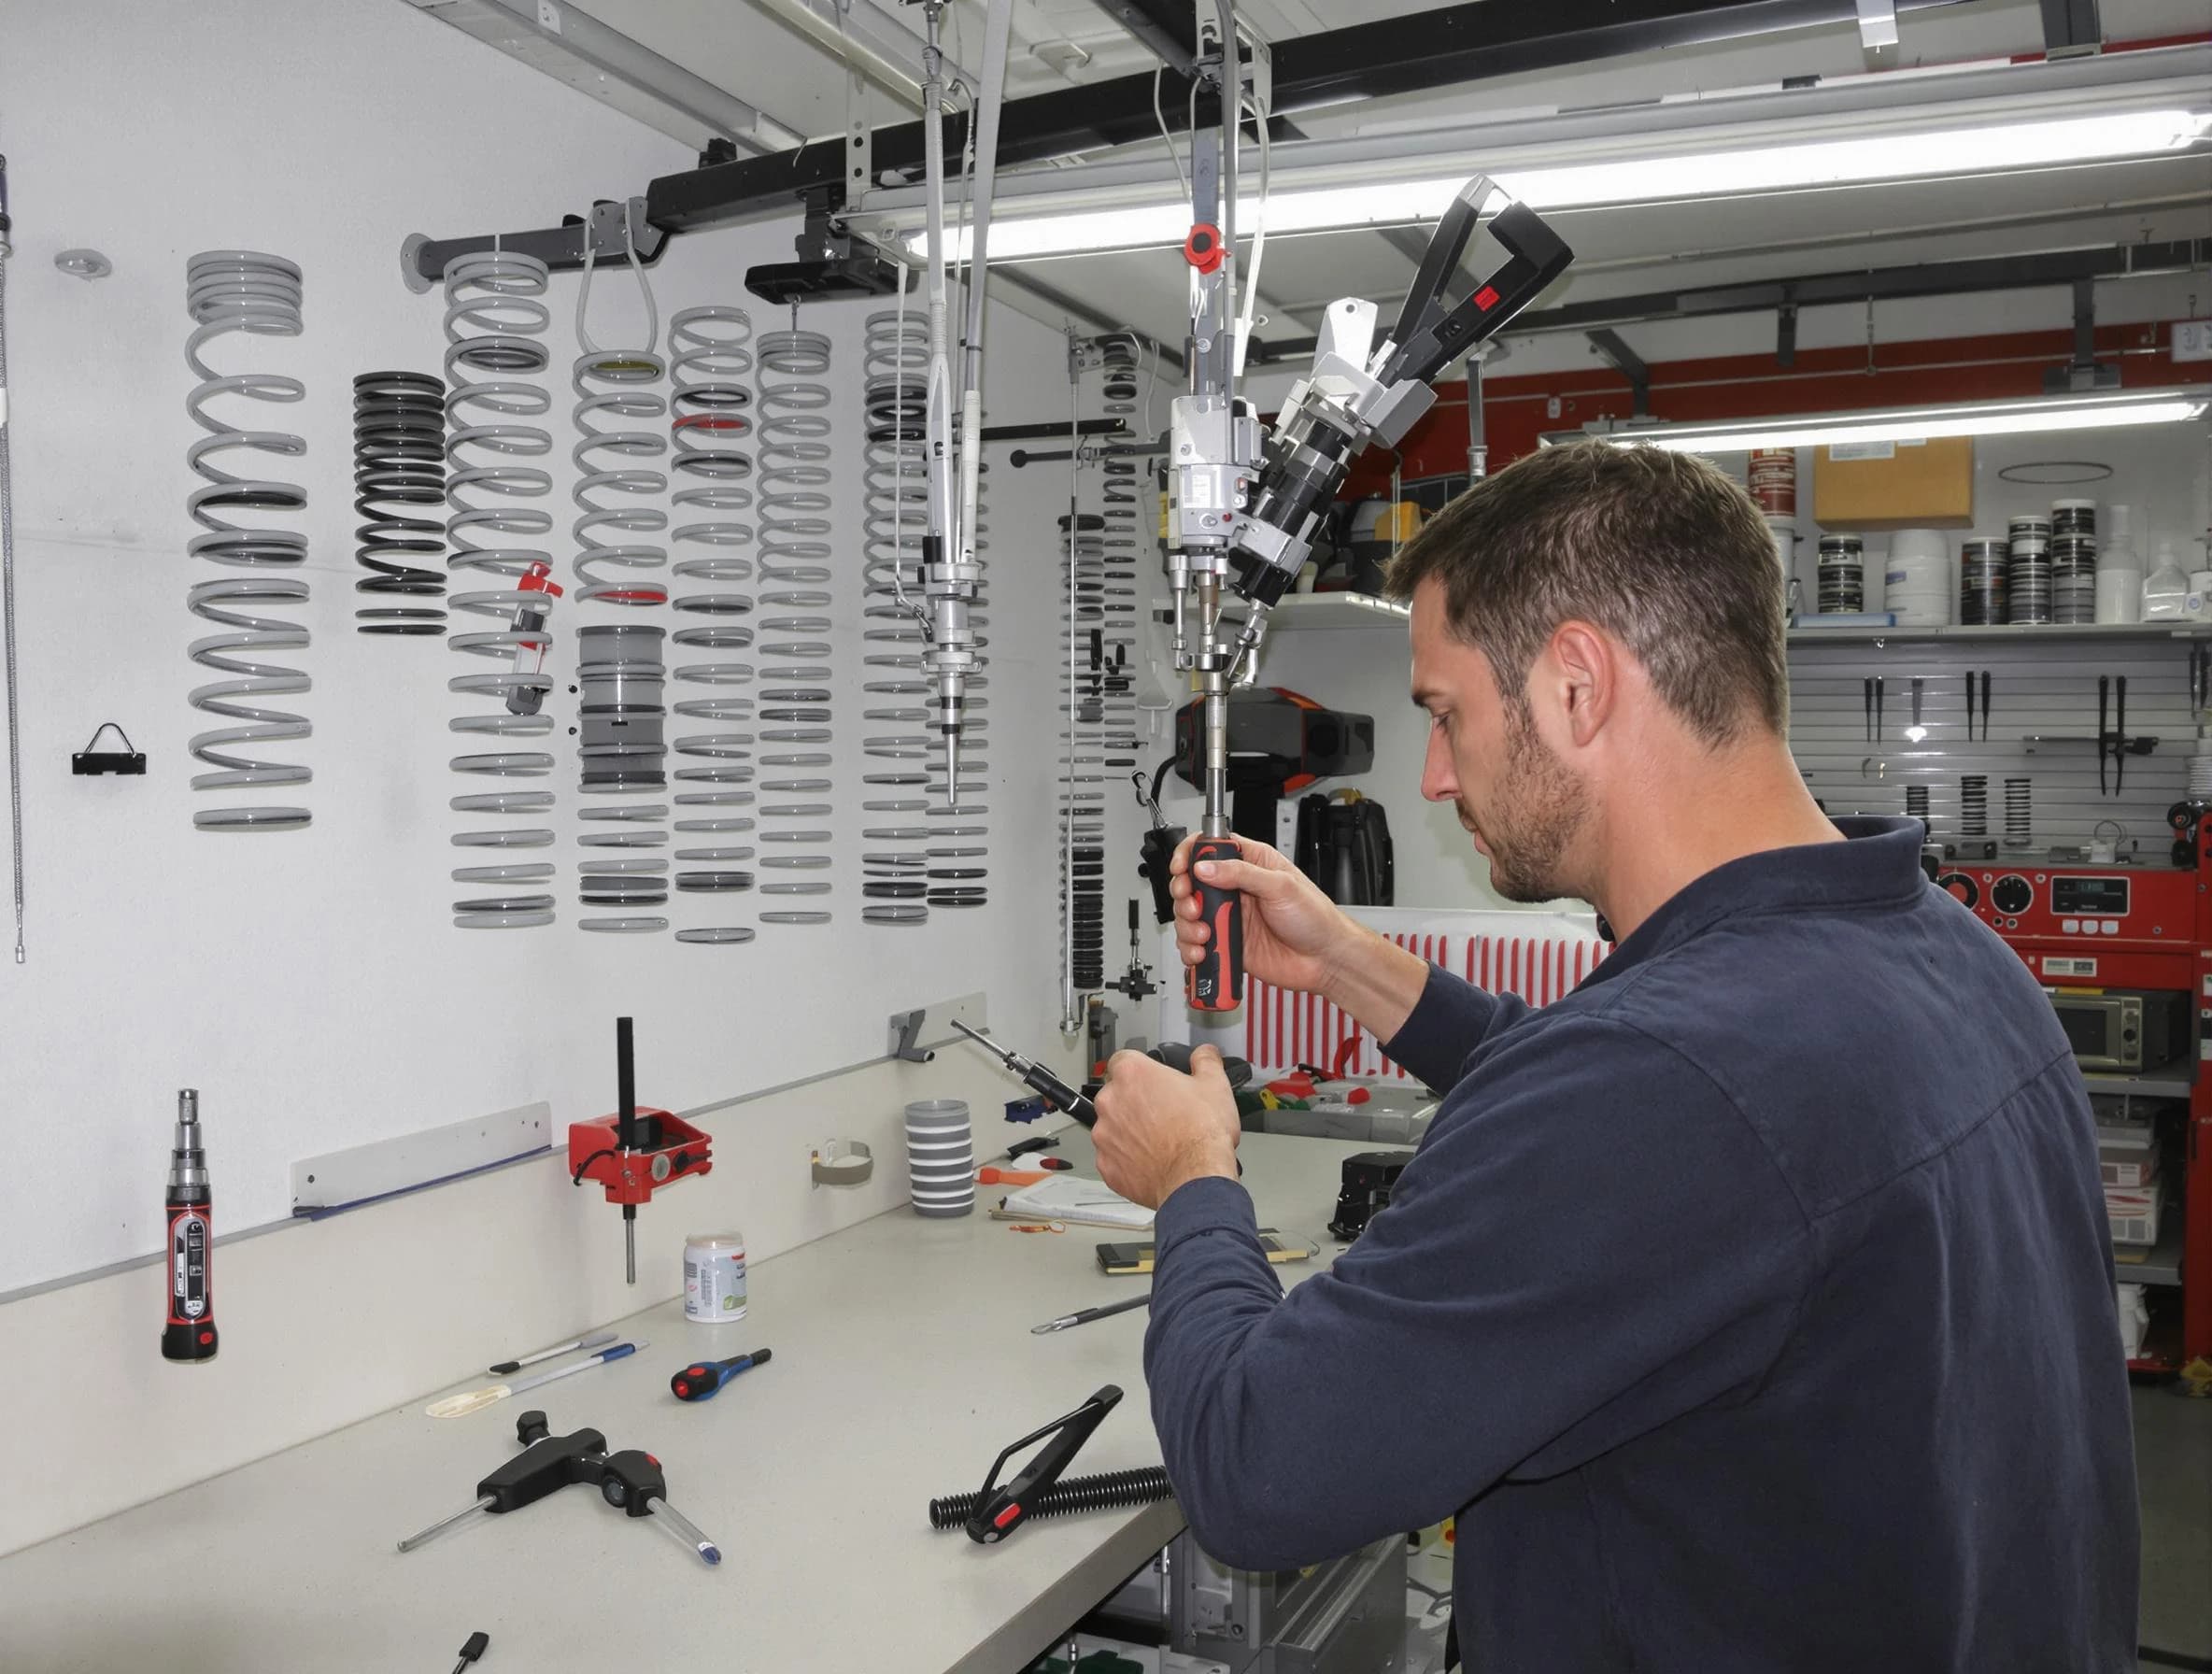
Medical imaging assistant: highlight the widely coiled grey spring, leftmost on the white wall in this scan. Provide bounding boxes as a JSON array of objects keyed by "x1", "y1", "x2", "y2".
[{"x1": 184, "y1": 249, "x2": 314, "y2": 831}]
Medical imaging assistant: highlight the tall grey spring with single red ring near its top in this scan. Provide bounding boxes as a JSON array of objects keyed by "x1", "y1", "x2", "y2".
[{"x1": 668, "y1": 305, "x2": 754, "y2": 944}]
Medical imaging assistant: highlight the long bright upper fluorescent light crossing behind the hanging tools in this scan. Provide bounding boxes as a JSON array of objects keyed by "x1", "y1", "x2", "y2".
[{"x1": 905, "y1": 108, "x2": 2212, "y2": 261}]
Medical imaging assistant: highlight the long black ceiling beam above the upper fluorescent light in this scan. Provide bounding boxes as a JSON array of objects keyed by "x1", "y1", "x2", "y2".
[{"x1": 645, "y1": 0, "x2": 1960, "y2": 233}]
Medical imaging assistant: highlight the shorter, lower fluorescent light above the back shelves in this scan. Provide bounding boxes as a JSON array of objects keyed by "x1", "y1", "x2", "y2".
[{"x1": 1541, "y1": 387, "x2": 2212, "y2": 453}]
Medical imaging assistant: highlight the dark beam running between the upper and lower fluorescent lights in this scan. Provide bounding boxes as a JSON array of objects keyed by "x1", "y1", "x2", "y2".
[{"x1": 1252, "y1": 239, "x2": 2212, "y2": 361}]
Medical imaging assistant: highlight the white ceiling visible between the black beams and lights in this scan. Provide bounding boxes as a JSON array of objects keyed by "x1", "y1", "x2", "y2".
[{"x1": 411, "y1": 0, "x2": 2212, "y2": 343}]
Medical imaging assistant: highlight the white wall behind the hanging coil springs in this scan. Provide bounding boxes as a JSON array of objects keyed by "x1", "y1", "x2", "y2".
[{"x1": 0, "y1": 0, "x2": 1088, "y2": 1282}]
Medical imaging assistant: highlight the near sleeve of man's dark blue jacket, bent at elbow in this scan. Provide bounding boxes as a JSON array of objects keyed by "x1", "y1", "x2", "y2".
[{"x1": 1143, "y1": 1013, "x2": 1808, "y2": 1570}]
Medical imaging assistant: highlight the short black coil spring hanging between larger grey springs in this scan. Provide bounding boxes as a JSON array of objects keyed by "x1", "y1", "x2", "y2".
[{"x1": 354, "y1": 372, "x2": 445, "y2": 634}]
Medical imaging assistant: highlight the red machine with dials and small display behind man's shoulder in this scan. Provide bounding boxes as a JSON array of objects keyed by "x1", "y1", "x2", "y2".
[{"x1": 1936, "y1": 849, "x2": 2212, "y2": 1371}]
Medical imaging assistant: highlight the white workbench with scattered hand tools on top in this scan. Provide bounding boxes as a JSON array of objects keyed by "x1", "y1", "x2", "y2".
[{"x1": 0, "y1": 1130, "x2": 1363, "y2": 1674}]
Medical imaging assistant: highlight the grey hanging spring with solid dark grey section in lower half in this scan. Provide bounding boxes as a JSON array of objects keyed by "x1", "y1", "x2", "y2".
[{"x1": 569, "y1": 229, "x2": 668, "y2": 933}]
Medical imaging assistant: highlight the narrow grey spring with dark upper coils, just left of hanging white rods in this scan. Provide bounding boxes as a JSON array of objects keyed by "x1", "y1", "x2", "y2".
[{"x1": 860, "y1": 309, "x2": 936, "y2": 925}]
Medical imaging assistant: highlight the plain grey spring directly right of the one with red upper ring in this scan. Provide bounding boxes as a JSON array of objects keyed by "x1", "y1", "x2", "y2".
[{"x1": 759, "y1": 327, "x2": 836, "y2": 925}]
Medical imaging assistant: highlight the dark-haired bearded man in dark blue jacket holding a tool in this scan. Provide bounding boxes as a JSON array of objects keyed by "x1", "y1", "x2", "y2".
[{"x1": 1098, "y1": 445, "x2": 2136, "y2": 1674}]
